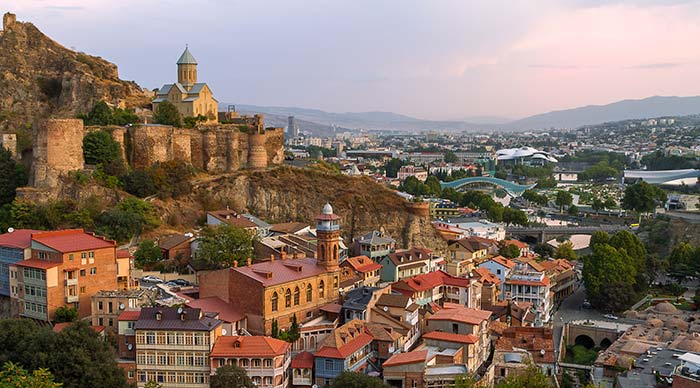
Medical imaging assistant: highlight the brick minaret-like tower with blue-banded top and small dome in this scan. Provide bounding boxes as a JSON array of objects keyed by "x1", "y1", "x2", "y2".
[{"x1": 316, "y1": 203, "x2": 340, "y2": 271}]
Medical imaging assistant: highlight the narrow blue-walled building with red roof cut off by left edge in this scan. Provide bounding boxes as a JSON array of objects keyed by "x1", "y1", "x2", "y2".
[{"x1": 0, "y1": 229, "x2": 38, "y2": 315}]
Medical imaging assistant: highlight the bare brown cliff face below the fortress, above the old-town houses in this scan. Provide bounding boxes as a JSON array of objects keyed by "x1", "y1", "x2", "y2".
[{"x1": 155, "y1": 167, "x2": 446, "y2": 251}]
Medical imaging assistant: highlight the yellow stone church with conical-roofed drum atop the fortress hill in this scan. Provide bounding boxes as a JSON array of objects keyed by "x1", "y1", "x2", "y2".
[{"x1": 152, "y1": 47, "x2": 219, "y2": 122}]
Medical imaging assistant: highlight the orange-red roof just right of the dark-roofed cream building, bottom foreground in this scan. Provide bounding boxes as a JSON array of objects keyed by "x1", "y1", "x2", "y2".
[{"x1": 210, "y1": 336, "x2": 292, "y2": 357}]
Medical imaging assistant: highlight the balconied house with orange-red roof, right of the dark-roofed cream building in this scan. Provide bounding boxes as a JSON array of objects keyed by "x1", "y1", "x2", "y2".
[{"x1": 209, "y1": 336, "x2": 292, "y2": 388}]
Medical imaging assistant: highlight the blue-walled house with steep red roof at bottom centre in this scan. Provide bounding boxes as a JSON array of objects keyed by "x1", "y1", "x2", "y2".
[{"x1": 314, "y1": 319, "x2": 377, "y2": 387}]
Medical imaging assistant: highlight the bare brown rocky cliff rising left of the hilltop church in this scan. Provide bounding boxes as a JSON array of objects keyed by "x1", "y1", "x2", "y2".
[{"x1": 0, "y1": 14, "x2": 149, "y2": 129}]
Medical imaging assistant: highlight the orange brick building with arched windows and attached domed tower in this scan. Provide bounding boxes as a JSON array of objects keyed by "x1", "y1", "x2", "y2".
[{"x1": 199, "y1": 204, "x2": 340, "y2": 335}]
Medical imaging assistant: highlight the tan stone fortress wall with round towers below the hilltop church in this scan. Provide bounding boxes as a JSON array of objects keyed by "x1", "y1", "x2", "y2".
[{"x1": 30, "y1": 115, "x2": 284, "y2": 188}]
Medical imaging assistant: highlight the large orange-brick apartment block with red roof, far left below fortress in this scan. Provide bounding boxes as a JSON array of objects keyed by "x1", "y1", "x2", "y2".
[{"x1": 9, "y1": 229, "x2": 117, "y2": 321}]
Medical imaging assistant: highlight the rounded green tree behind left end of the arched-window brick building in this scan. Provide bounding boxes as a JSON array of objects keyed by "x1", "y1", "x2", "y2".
[{"x1": 197, "y1": 224, "x2": 253, "y2": 268}]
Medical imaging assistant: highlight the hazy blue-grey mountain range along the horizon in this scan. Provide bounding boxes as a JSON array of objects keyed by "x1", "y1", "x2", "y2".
[{"x1": 221, "y1": 96, "x2": 700, "y2": 136}]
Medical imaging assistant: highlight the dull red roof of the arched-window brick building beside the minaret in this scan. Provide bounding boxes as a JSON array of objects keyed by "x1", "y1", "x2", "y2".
[{"x1": 231, "y1": 257, "x2": 326, "y2": 287}]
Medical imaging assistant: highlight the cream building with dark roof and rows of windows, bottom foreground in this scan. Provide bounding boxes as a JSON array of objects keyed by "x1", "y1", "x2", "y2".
[{"x1": 134, "y1": 307, "x2": 222, "y2": 388}]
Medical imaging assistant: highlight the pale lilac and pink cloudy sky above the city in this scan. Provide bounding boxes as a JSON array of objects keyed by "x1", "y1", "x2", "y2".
[{"x1": 5, "y1": 0, "x2": 700, "y2": 119}]
